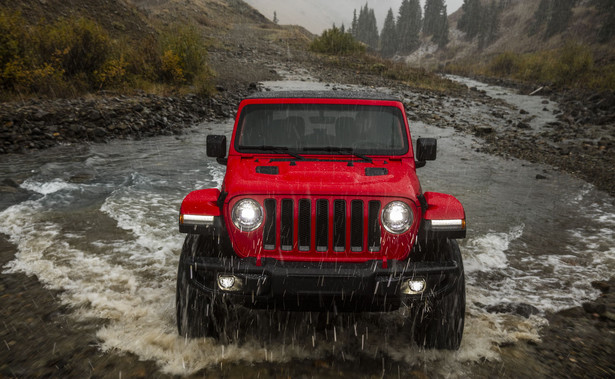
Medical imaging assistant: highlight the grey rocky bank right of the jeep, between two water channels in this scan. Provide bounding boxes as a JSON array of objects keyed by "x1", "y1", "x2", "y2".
[{"x1": 475, "y1": 80, "x2": 615, "y2": 196}]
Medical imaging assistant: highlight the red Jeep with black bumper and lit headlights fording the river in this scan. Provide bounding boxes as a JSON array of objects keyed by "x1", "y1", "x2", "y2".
[{"x1": 176, "y1": 91, "x2": 466, "y2": 349}]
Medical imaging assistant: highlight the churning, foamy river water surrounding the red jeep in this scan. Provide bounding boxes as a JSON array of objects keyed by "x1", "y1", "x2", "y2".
[{"x1": 0, "y1": 81, "x2": 615, "y2": 376}]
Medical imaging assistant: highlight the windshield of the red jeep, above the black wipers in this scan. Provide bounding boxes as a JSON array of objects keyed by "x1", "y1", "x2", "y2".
[{"x1": 235, "y1": 104, "x2": 408, "y2": 155}]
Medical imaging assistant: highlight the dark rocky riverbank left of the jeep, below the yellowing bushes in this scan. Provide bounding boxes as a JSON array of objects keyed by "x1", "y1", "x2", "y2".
[{"x1": 0, "y1": 88, "x2": 256, "y2": 154}]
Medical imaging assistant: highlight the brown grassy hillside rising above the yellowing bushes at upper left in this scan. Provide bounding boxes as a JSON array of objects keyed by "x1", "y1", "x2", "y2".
[{"x1": 0, "y1": 0, "x2": 311, "y2": 93}]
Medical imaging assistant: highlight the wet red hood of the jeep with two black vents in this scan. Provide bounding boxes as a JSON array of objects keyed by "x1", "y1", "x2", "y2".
[{"x1": 223, "y1": 157, "x2": 419, "y2": 198}]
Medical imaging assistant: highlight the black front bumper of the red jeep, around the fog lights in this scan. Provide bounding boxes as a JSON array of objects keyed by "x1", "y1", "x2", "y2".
[{"x1": 180, "y1": 257, "x2": 462, "y2": 311}]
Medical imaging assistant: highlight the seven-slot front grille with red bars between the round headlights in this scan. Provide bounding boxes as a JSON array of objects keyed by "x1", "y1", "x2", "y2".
[{"x1": 263, "y1": 199, "x2": 381, "y2": 253}]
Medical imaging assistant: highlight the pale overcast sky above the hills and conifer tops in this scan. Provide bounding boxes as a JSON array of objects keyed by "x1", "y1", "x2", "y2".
[{"x1": 245, "y1": 0, "x2": 463, "y2": 34}]
